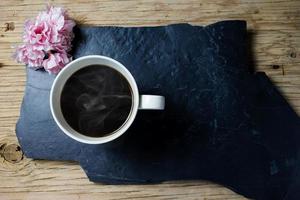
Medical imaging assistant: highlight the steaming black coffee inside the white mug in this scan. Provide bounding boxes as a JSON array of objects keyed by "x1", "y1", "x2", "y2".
[{"x1": 60, "y1": 65, "x2": 132, "y2": 137}]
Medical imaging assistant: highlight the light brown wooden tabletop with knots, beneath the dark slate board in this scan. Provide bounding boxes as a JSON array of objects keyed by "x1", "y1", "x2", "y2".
[{"x1": 0, "y1": 0, "x2": 300, "y2": 200}]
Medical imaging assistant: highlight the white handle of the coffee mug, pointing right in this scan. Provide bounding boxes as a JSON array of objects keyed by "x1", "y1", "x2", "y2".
[{"x1": 139, "y1": 95, "x2": 165, "y2": 110}]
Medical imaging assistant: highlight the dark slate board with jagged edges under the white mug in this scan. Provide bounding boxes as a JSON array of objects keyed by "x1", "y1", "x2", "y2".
[{"x1": 16, "y1": 21, "x2": 300, "y2": 199}]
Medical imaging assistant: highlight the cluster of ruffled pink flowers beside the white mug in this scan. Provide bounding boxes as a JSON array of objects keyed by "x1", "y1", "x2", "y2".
[{"x1": 14, "y1": 6, "x2": 75, "y2": 74}]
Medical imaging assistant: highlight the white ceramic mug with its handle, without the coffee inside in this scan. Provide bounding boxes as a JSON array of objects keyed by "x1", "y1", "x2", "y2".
[{"x1": 50, "y1": 55, "x2": 165, "y2": 144}]
